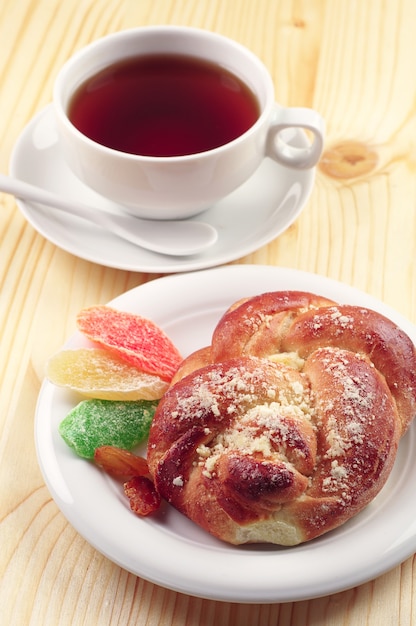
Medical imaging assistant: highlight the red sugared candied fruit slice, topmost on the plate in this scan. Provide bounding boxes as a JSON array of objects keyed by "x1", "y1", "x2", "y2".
[{"x1": 77, "y1": 306, "x2": 182, "y2": 382}]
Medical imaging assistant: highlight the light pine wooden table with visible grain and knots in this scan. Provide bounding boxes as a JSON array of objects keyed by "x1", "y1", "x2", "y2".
[{"x1": 0, "y1": 0, "x2": 416, "y2": 626}]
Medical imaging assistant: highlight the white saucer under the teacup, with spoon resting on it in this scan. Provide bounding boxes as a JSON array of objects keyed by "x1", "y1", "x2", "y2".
[{"x1": 10, "y1": 105, "x2": 315, "y2": 273}]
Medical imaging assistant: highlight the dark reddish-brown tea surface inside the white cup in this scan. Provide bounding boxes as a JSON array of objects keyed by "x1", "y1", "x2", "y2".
[{"x1": 69, "y1": 54, "x2": 259, "y2": 157}]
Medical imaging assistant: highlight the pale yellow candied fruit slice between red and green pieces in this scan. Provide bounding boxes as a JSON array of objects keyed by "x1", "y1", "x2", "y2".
[{"x1": 46, "y1": 348, "x2": 169, "y2": 400}]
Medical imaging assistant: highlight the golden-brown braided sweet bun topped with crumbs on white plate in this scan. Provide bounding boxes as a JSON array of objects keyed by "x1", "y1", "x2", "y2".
[{"x1": 148, "y1": 291, "x2": 416, "y2": 545}]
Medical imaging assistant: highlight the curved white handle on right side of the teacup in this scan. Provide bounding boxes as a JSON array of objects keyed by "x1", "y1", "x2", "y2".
[{"x1": 266, "y1": 107, "x2": 325, "y2": 169}]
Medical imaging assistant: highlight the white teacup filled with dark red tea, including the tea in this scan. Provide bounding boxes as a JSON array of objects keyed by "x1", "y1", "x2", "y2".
[{"x1": 53, "y1": 26, "x2": 324, "y2": 219}]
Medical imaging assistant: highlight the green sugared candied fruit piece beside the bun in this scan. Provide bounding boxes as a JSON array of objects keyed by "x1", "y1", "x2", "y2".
[{"x1": 59, "y1": 399, "x2": 158, "y2": 459}]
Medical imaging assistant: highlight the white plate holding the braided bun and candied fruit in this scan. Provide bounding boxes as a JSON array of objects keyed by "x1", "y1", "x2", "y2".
[{"x1": 35, "y1": 265, "x2": 416, "y2": 603}]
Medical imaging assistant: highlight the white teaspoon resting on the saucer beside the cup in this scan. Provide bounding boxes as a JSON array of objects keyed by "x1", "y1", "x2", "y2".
[{"x1": 0, "y1": 174, "x2": 218, "y2": 256}]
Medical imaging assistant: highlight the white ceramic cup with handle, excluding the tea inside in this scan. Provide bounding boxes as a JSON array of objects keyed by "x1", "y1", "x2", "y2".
[{"x1": 53, "y1": 26, "x2": 324, "y2": 219}]
